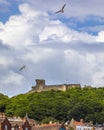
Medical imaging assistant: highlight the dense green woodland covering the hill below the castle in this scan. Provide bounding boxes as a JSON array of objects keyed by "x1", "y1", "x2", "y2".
[{"x1": 0, "y1": 87, "x2": 104, "y2": 123}]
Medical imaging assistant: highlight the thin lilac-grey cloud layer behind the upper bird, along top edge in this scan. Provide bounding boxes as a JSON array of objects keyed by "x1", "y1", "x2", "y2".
[{"x1": 19, "y1": 0, "x2": 104, "y2": 19}]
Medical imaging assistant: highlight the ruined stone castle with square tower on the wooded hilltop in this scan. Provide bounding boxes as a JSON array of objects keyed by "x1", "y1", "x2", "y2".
[{"x1": 29, "y1": 79, "x2": 81, "y2": 92}]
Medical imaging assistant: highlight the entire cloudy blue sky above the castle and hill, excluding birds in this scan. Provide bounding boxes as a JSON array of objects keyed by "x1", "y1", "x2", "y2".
[{"x1": 0, "y1": 0, "x2": 104, "y2": 97}]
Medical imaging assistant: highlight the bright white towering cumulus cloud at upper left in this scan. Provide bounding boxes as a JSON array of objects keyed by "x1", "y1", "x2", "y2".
[{"x1": 0, "y1": 4, "x2": 47, "y2": 48}]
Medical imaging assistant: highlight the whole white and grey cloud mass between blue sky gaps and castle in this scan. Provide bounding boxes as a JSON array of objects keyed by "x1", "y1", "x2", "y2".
[{"x1": 0, "y1": 0, "x2": 104, "y2": 96}]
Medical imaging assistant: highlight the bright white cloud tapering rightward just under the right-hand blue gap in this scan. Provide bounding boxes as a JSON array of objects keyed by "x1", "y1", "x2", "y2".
[{"x1": 39, "y1": 21, "x2": 95, "y2": 43}]
